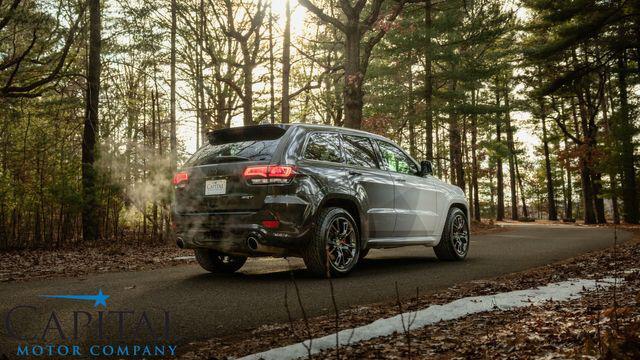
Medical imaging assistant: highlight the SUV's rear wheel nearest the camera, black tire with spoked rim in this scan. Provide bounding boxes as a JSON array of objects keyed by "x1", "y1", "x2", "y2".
[{"x1": 302, "y1": 207, "x2": 360, "y2": 277}]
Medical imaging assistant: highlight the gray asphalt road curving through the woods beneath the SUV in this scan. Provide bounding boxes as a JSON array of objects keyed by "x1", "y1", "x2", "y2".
[{"x1": 0, "y1": 224, "x2": 631, "y2": 354}]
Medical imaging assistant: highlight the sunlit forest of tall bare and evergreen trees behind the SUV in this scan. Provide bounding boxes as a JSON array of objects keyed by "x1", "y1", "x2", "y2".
[{"x1": 0, "y1": 0, "x2": 640, "y2": 249}]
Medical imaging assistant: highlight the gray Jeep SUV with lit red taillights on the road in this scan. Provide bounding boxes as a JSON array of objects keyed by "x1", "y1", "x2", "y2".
[{"x1": 172, "y1": 124, "x2": 469, "y2": 276}]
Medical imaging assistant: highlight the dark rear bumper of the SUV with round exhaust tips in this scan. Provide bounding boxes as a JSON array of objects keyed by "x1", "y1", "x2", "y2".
[{"x1": 173, "y1": 196, "x2": 313, "y2": 256}]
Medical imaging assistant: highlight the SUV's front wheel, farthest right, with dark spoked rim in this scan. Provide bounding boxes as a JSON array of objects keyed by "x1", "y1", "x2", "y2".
[{"x1": 433, "y1": 207, "x2": 469, "y2": 261}]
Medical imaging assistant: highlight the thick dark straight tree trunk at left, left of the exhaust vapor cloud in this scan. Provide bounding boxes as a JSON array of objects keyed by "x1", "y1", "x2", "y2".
[{"x1": 82, "y1": 0, "x2": 101, "y2": 245}]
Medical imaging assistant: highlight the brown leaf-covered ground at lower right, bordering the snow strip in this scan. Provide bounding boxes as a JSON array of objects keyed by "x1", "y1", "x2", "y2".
[{"x1": 183, "y1": 227, "x2": 640, "y2": 359}]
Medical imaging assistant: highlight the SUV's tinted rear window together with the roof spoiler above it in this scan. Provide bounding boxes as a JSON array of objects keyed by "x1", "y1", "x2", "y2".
[{"x1": 185, "y1": 126, "x2": 286, "y2": 166}]
